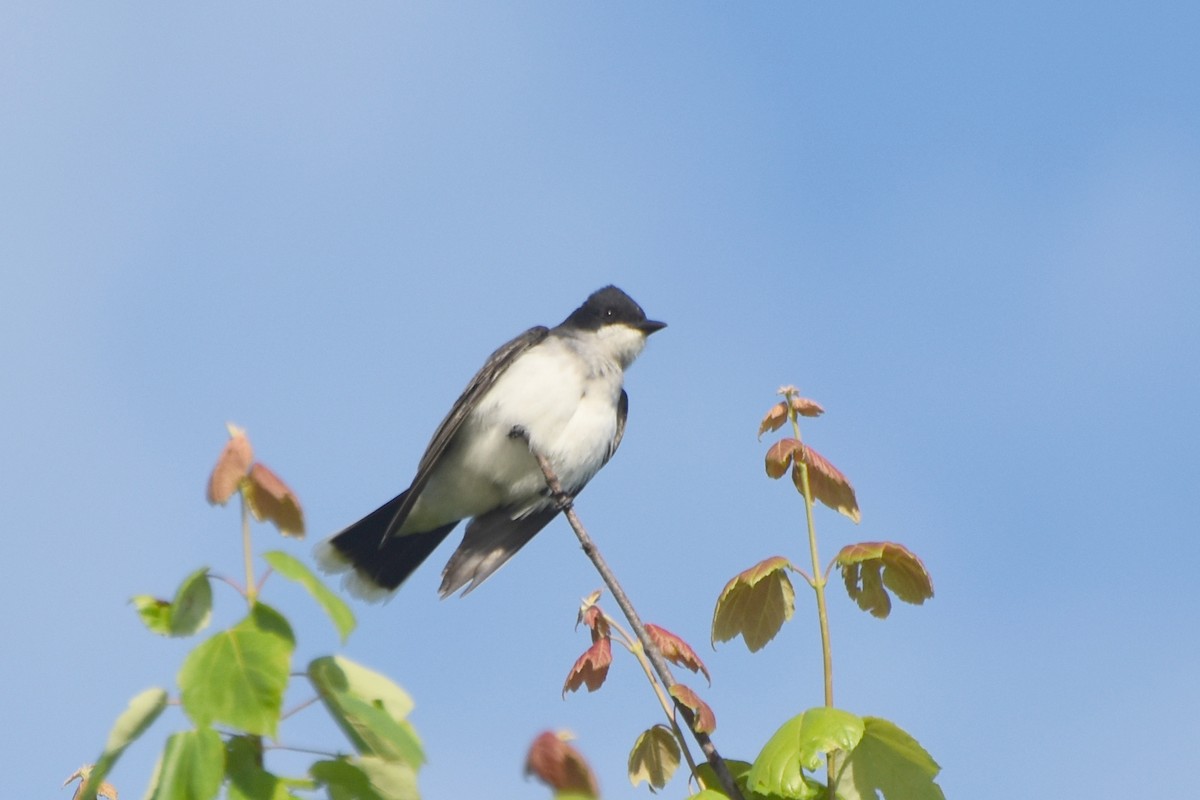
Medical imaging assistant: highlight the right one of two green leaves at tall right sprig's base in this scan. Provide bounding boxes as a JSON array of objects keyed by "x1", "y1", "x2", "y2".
[{"x1": 838, "y1": 717, "x2": 946, "y2": 800}]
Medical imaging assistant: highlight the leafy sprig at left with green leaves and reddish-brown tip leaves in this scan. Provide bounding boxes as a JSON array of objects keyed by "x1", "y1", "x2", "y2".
[{"x1": 72, "y1": 426, "x2": 425, "y2": 800}]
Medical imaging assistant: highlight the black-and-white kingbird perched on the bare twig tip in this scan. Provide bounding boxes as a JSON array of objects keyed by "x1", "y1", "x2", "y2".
[{"x1": 317, "y1": 287, "x2": 666, "y2": 600}]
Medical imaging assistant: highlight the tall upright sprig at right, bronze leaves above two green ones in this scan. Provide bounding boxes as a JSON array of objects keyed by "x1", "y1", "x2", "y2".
[{"x1": 712, "y1": 386, "x2": 943, "y2": 800}]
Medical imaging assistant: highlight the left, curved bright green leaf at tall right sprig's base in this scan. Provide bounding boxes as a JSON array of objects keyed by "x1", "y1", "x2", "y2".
[{"x1": 746, "y1": 706, "x2": 863, "y2": 800}]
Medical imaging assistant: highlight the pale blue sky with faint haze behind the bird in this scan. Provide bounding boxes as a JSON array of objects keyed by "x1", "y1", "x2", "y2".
[{"x1": 0, "y1": 0, "x2": 1200, "y2": 800}]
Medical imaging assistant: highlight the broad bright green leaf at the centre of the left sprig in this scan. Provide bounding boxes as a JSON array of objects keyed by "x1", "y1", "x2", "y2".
[{"x1": 179, "y1": 603, "x2": 295, "y2": 736}]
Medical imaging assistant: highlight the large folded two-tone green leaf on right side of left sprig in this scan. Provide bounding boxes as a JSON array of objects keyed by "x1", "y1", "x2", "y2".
[{"x1": 308, "y1": 656, "x2": 425, "y2": 768}]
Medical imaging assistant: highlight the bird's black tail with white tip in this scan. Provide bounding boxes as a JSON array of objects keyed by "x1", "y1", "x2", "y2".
[{"x1": 317, "y1": 494, "x2": 458, "y2": 601}]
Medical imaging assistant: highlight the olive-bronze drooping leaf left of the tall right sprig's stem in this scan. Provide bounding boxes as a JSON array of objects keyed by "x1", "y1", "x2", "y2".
[{"x1": 713, "y1": 555, "x2": 796, "y2": 652}]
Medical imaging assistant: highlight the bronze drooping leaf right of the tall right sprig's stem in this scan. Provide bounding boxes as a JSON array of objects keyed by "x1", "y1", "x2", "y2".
[{"x1": 834, "y1": 542, "x2": 934, "y2": 619}]
